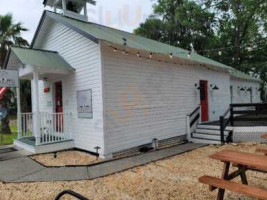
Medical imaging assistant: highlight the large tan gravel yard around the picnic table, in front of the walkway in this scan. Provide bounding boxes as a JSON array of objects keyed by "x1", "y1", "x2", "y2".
[{"x1": 0, "y1": 144, "x2": 267, "y2": 200}]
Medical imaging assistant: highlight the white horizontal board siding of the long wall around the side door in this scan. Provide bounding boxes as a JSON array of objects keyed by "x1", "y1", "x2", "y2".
[{"x1": 102, "y1": 47, "x2": 230, "y2": 153}]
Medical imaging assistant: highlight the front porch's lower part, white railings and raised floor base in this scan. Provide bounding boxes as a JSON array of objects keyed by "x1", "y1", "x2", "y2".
[{"x1": 14, "y1": 113, "x2": 73, "y2": 153}]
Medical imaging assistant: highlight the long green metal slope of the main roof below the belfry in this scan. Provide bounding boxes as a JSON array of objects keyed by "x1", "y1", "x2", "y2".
[{"x1": 46, "y1": 11, "x2": 233, "y2": 69}]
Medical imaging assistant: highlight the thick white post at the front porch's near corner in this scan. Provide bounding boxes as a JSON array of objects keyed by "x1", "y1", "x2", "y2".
[{"x1": 32, "y1": 70, "x2": 41, "y2": 145}]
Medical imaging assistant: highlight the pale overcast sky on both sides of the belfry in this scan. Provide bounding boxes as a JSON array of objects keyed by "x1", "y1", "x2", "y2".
[{"x1": 0, "y1": 0, "x2": 152, "y2": 42}]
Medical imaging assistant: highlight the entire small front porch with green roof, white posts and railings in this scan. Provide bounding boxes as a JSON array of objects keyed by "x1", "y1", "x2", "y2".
[{"x1": 7, "y1": 47, "x2": 74, "y2": 153}]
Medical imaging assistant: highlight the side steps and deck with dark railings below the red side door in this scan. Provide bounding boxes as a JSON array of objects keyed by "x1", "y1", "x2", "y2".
[{"x1": 187, "y1": 103, "x2": 267, "y2": 144}]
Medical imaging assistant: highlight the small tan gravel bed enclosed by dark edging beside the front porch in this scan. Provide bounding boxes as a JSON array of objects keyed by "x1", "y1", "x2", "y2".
[{"x1": 31, "y1": 150, "x2": 102, "y2": 167}]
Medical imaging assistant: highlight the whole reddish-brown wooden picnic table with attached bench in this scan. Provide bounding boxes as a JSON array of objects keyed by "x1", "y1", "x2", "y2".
[{"x1": 199, "y1": 151, "x2": 267, "y2": 200}]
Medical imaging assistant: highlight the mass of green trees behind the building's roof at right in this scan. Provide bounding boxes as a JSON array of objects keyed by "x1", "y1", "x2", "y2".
[{"x1": 135, "y1": 0, "x2": 267, "y2": 90}]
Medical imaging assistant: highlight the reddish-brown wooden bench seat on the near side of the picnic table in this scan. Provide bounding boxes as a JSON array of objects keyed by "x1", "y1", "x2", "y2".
[{"x1": 199, "y1": 176, "x2": 267, "y2": 200}]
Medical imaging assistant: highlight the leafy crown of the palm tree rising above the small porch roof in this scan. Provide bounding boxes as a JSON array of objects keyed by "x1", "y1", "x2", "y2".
[{"x1": 0, "y1": 14, "x2": 29, "y2": 68}]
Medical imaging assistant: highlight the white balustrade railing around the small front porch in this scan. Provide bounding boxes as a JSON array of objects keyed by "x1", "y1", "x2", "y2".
[{"x1": 19, "y1": 113, "x2": 72, "y2": 145}]
